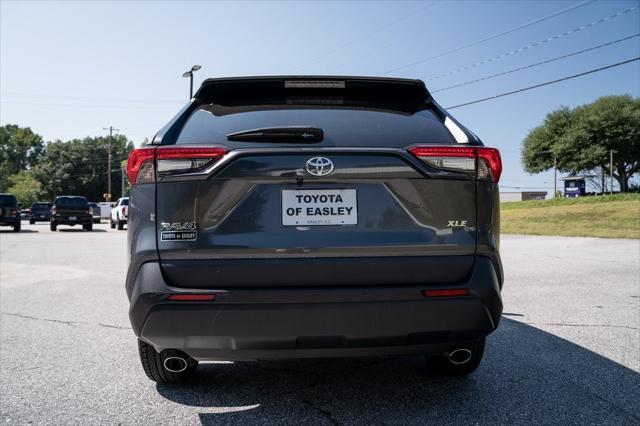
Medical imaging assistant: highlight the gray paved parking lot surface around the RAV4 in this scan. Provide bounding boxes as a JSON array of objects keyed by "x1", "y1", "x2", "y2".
[{"x1": 0, "y1": 224, "x2": 640, "y2": 424}]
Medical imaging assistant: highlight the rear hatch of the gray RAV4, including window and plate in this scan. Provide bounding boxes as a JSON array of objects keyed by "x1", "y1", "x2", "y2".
[{"x1": 151, "y1": 80, "x2": 484, "y2": 288}]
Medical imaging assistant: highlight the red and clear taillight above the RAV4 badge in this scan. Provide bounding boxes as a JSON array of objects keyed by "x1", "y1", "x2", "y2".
[{"x1": 127, "y1": 146, "x2": 227, "y2": 185}]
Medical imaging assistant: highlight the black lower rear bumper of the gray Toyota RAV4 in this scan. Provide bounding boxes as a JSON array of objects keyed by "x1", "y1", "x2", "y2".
[{"x1": 129, "y1": 257, "x2": 502, "y2": 360}]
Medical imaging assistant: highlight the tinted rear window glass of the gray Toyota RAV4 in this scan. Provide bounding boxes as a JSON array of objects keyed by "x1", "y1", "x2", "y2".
[{"x1": 177, "y1": 105, "x2": 454, "y2": 147}]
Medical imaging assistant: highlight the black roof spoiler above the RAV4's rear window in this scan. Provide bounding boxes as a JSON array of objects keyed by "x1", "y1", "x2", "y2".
[{"x1": 194, "y1": 76, "x2": 431, "y2": 111}]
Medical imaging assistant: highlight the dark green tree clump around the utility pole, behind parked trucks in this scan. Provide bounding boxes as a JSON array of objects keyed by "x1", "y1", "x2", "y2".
[{"x1": 34, "y1": 135, "x2": 133, "y2": 201}]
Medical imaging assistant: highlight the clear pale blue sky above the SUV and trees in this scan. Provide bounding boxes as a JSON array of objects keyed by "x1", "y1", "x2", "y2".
[{"x1": 0, "y1": 0, "x2": 640, "y2": 194}]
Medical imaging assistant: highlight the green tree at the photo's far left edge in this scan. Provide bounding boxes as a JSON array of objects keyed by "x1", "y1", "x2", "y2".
[{"x1": 0, "y1": 124, "x2": 44, "y2": 192}]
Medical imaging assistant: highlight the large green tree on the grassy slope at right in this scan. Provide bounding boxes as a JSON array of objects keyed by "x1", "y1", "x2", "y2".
[{"x1": 522, "y1": 95, "x2": 640, "y2": 192}]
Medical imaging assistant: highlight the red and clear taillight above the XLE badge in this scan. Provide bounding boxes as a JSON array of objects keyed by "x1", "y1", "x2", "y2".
[{"x1": 409, "y1": 146, "x2": 502, "y2": 183}]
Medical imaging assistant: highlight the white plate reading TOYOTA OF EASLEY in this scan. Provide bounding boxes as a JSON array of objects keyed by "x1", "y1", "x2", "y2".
[{"x1": 282, "y1": 189, "x2": 358, "y2": 226}]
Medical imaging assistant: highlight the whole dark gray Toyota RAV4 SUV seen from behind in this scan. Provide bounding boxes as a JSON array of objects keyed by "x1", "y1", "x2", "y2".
[{"x1": 126, "y1": 76, "x2": 503, "y2": 383}]
